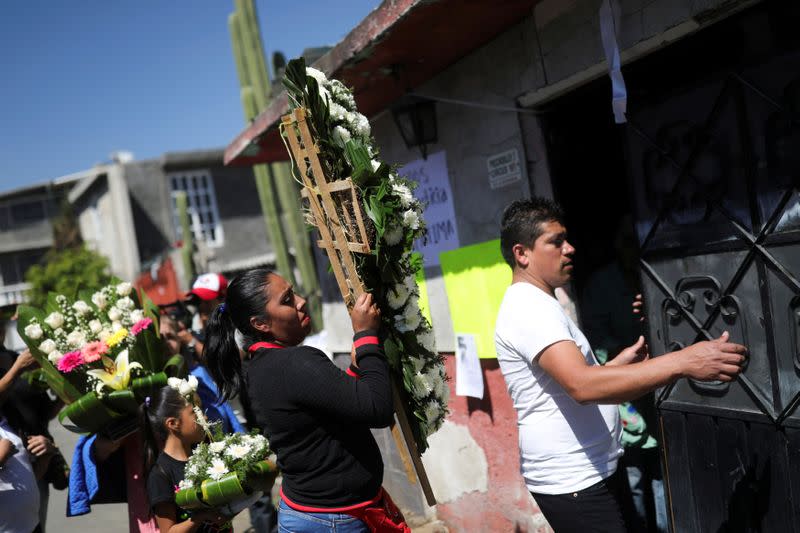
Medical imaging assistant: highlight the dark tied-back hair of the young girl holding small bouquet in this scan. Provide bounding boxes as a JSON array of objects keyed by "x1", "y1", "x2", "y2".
[{"x1": 139, "y1": 385, "x2": 188, "y2": 473}]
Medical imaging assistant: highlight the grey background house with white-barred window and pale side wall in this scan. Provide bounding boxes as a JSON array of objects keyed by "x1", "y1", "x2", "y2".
[{"x1": 69, "y1": 150, "x2": 274, "y2": 303}]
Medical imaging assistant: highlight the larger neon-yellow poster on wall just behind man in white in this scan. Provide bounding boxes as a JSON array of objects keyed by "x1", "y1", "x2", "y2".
[{"x1": 439, "y1": 239, "x2": 511, "y2": 359}]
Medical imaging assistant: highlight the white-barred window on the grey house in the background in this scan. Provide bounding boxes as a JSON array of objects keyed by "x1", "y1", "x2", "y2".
[{"x1": 169, "y1": 170, "x2": 224, "y2": 246}]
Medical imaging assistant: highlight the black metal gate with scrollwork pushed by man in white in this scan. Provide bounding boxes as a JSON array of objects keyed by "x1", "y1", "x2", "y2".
[{"x1": 627, "y1": 47, "x2": 800, "y2": 533}]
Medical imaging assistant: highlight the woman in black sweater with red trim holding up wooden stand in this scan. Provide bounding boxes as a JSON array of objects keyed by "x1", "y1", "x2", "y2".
[{"x1": 204, "y1": 269, "x2": 410, "y2": 533}]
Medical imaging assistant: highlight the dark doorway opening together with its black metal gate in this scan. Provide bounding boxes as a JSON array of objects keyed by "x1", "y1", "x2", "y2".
[{"x1": 545, "y1": 1, "x2": 800, "y2": 532}]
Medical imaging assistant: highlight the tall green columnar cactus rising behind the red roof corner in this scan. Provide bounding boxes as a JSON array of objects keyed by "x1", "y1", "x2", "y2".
[{"x1": 228, "y1": 0, "x2": 322, "y2": 327}]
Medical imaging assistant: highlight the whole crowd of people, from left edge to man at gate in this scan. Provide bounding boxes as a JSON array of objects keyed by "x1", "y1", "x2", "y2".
[{"x1": 0, "y1": 198, "x2": 746, "y2": 533}]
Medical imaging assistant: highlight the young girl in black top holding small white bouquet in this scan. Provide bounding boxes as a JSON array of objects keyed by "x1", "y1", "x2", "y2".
[{"x1": 142, "y1": 386, "x2": 232, "y2": 533}]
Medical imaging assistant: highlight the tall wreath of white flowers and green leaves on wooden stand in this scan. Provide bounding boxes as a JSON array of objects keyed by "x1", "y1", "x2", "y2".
[{"x1": 282, "y1": 59, "x2": 449, "y2": 453}]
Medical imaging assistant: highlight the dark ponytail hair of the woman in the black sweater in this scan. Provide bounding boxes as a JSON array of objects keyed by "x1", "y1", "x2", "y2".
[{"x1": 203, "y1": 268, "x2": 272, "y2": 400}]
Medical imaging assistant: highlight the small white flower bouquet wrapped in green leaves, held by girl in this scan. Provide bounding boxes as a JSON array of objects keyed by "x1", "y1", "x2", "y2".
[{"x1": 175, "y1": 428, "x2": 275, "y2": 516}]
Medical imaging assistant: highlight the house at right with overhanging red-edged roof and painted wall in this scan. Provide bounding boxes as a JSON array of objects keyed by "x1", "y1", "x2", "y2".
[{"x1": 226, "y1": 0, "x2": 800, "y2": 531}]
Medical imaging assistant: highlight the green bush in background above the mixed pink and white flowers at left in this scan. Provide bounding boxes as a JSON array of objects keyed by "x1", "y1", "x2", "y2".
[{"x1": 25, "y1": 246, "x2": 111, "y2": 308}]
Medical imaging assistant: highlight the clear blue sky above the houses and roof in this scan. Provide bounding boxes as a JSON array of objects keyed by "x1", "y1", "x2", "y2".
[{"x1": 0, "y1": 0, "x2": 380, "y2": 192}]
